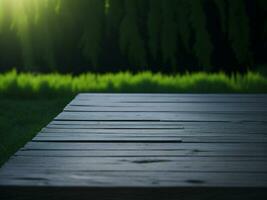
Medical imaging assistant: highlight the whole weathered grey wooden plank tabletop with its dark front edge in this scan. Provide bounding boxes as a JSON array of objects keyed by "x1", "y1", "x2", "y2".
[{"x1": 0, "y1": 94, "x2": 267, "y2": 200}]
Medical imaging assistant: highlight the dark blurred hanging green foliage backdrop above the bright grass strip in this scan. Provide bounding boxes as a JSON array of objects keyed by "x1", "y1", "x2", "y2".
[{"x1": 0, "y1": 0, "x2": 267, "y2": 73}]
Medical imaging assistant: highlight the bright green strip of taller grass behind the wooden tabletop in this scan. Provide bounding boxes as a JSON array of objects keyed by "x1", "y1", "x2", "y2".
[{"x1": 0, "y1": 71, "x2": 267, "y2": 98}]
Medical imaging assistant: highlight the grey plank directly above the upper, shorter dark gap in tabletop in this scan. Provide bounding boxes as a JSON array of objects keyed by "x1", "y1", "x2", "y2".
[{"x1": 55, "y1": 112, "x2": 267, "y2": 122}]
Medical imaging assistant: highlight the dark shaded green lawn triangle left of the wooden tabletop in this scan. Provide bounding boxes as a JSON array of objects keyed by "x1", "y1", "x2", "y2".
[{"x1": 0, "y1": 98, "x2": 73, "y2": 166}]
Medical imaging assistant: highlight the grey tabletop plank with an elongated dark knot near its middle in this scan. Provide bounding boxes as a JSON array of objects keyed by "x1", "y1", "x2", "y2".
[{"x1": 3, "y1": 156, "x2": 267, "y2": 172}]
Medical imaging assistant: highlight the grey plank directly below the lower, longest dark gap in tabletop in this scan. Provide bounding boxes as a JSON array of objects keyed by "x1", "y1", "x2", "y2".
[{"x1": 23, "y1": 142, "x2": 267, "y2": 151}]
